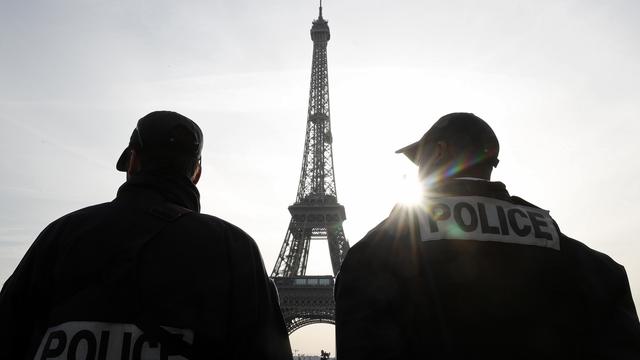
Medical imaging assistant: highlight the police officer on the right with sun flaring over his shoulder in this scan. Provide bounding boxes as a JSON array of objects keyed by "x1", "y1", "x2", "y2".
[{"x1": 335, "y1": 113, "x2": 640, "y2": 360}]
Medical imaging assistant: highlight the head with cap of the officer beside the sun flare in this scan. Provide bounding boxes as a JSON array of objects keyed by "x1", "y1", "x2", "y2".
[{"x1": 396, "y1": 113, "x2": 500, "y2": 182}]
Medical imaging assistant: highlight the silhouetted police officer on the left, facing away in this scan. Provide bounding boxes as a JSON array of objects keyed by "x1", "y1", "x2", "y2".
[{"x1": 0, "y1": 111, "x2": 291, "y2": 360}]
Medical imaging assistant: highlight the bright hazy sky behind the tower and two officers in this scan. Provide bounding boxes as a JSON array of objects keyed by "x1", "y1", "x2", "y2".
[{"x1": 0, "y1": 0, "x2": 640, "y2": 354}]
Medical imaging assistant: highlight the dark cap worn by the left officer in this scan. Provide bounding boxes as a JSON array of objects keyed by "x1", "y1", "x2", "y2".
[{"x1": 116, "y1": 111, "x2": 202, "y2": 171}]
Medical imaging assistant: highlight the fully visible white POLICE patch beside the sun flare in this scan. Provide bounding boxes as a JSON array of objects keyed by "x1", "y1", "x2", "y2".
[{"x1": 418, "y1": 196, "x2": 560, "y2": 250}]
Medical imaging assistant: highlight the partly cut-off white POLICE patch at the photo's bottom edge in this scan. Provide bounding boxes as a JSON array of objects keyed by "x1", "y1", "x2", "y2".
[{"x1": 34, "y1": 321, "x2": 193, "y2": 360}]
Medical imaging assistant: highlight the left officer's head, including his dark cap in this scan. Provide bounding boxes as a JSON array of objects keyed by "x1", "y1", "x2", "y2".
[{"x1": 116, "y1": 111, "x2": 202, "y2": 184}]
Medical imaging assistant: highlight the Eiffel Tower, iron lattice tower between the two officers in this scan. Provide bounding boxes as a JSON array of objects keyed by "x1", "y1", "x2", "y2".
[{"x1": 271, "y1": 0, "x2": 349, "y2": 334}]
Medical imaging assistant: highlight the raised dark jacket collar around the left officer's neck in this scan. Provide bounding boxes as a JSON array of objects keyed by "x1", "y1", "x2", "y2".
[{"x1": 117, "y1": 174, "x2": 200, "y2": 212}]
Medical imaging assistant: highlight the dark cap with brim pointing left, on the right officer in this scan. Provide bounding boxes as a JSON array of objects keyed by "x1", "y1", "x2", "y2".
[{"x1": 396, "y1": 113, "x2": 500, "y2": 167}]
